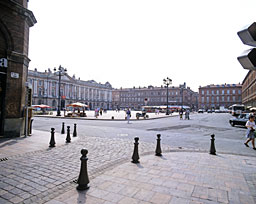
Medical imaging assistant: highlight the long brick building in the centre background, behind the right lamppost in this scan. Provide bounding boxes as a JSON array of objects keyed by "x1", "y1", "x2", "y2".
[{"x1": 112, "y1": 83, "x2": 198, "y2": 110}]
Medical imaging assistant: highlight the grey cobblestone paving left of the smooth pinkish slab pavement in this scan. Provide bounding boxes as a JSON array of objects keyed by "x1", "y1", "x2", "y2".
[{"x1": 0, "y1": 132, "x2": 172, "y2": 203}]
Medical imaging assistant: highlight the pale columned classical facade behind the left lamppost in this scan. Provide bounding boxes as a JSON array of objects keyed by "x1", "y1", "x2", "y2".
[{"x1": 28, "y1": 69, "x2": 112, "y2": 109}]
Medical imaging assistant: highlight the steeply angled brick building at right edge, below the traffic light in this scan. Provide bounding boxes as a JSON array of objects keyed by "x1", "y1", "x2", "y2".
[{"x1": 242, "y1": 71, "x2": 256, "y2": 107}]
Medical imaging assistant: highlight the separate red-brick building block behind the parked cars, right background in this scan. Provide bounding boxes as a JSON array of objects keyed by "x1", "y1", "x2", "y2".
[{"x1": 198, "y1": 84, "x2": 242, "y2": 109}]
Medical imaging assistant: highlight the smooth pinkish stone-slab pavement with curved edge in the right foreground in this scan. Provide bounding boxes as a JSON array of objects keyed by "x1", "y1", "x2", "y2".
[{"x1": 47, "y1": 152, "x2": 256, "y2": 204}]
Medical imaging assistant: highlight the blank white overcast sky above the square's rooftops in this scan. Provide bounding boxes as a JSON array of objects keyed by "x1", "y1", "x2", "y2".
[{"x1": 28, "y1": 0, "x2": 256, "y2": 91}]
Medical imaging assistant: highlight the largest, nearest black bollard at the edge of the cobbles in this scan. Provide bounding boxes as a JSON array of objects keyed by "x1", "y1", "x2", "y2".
[{"x1": 76, "y1": 149, "x2": 89, "y2": 190}]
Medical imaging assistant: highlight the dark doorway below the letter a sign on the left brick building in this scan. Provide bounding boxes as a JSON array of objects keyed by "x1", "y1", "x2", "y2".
[{"x1": 0, "y1": 70, "x2": 6, "y2": 135}]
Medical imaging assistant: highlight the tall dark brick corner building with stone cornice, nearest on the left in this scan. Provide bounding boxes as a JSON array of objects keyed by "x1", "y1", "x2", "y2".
[{"x1": 0, "y1": 0, "x2": 36, "y2": 137}]
